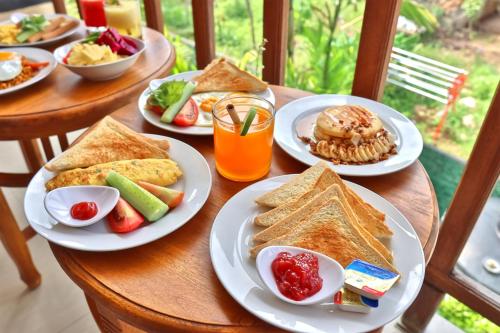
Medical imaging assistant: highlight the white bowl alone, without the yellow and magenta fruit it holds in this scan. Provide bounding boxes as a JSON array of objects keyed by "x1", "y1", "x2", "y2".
[{"x1": 54, "y1": 37, "x2": 146, "y2": 81}]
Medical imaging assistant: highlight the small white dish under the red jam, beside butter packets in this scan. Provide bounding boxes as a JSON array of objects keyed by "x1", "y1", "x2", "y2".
[{"x1": 256, "y1": 246, "x2": 344, "y2": 305}]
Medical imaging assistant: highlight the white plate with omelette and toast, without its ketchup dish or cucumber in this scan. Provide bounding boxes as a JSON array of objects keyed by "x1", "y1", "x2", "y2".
[{"x1": 24, "y1": 117, "x2": 212, "y2": 251}]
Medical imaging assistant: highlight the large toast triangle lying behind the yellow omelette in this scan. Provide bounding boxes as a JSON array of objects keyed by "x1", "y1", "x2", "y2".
[{"x1": 45, "y1": 116, "x2": 169, "y2": 172}]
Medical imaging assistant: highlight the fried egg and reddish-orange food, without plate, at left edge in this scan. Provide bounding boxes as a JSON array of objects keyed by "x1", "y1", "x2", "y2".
[{"x1": 0, "y1": 52, "x2": 49, "y2": 90}]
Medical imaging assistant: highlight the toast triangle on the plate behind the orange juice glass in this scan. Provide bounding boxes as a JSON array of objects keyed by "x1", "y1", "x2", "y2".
[{"x1": 193, "y1": 58, "x2": 268, "y2": 93}]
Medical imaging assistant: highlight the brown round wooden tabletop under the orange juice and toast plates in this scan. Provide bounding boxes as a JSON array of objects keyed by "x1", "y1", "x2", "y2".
[{"x1": 51, "y1": 87, "x2": 438, "y2": 332}]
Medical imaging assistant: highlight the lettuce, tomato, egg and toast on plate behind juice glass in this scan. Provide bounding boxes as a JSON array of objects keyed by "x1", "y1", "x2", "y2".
[{"x1": 145, "y1": 58, "x2": 268, "y2": 127}]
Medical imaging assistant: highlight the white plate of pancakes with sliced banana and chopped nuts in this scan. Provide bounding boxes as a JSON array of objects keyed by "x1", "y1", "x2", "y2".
[{"x1": 274, "y1": 95, "x2": 423, "y2": 176}]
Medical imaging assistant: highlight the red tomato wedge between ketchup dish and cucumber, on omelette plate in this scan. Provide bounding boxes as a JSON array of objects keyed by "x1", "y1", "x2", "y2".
[{"x1": 106, "y1": 198, "x2": 144, "y2": 233}]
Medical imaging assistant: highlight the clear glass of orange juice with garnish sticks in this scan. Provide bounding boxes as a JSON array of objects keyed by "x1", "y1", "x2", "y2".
[{"x1": 212, "y1": 96, "x2": 275, "y2": 182}]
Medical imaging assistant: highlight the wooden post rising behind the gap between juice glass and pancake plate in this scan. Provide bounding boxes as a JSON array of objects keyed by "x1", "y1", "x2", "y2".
[{"x1": 262, "y1": 0, "x2": 290, "y2": 85}]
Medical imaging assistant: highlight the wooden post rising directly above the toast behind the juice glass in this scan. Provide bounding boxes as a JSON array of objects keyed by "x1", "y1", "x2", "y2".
[{"x1": 191, "y1": 0, "x2": 215, "y2": 69}]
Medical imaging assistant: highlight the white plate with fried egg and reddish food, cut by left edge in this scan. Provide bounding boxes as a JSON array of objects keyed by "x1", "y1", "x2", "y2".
[{"x1": 0, "y1": 47, "x2": 57, "y2": 95}]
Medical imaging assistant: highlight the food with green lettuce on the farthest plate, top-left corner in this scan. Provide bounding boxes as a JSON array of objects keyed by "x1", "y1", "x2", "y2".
[{"x1": 0, "y1": 15, "x2": 79, "y2": 44}]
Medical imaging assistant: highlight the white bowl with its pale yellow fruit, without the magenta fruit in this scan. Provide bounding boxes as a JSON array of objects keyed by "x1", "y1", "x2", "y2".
[{"x1": 54, "y1": 37, "x2": 145, "y2": 81}]
